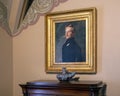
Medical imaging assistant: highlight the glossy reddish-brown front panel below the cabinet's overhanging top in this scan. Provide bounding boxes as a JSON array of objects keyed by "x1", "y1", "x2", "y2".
[{"x1": 28, "y1": 89, "x2": 90, "y2": 96}]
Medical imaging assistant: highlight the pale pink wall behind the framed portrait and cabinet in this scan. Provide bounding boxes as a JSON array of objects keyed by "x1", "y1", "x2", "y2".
[{"x1": 13, "y1": 0, "x2": 120, "y2": 96}]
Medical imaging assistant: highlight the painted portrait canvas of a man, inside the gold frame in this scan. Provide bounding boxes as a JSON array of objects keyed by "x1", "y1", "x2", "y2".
[{"x1": 55, "y1": 20, "x2": 86, "y2": 62}]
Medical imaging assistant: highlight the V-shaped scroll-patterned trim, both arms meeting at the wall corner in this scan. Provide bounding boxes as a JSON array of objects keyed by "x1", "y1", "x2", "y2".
[{"x1": 0, "y1": 0, "x2": 67, "y2": 37}]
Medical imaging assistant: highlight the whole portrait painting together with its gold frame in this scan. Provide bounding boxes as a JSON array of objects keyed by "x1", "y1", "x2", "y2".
[{"x1": 45, "y1": 8, "x2": 97, "y2": 74}]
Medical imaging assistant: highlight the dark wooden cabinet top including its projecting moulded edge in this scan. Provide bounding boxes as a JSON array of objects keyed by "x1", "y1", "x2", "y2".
[{"x1": 19, "y1": 80, "x2": 106, "y2": 89}]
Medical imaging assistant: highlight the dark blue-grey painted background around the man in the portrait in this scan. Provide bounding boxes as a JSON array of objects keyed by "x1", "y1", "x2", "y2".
[{"x1": 55, "y1": 20, "x2": 86, "y2": 62}]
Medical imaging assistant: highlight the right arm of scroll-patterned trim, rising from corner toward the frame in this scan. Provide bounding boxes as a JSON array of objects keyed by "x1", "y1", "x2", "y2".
[{"x1": 12, "y1": 0, "x2": 67, "y2": 36}]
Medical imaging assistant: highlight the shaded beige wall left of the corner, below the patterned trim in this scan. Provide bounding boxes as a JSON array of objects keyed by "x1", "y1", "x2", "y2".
[{"x1": 0, "y1": 28, "x2": 13, "y2": 96}]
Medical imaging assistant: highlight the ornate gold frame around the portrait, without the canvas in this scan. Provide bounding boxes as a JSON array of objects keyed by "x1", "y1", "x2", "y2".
[{"x1": 45, "y1": 8, "x2": 97, "y2": 74}]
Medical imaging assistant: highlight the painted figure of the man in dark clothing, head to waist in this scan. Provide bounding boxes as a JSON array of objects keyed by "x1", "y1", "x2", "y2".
[{"x1": 62, "y1": 24, "x2": 81, "y2": 62}]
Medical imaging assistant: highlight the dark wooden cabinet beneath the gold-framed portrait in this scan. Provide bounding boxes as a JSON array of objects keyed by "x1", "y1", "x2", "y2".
[{"x1": 20, "y1": 81, "x2": 106, "y2": 96}]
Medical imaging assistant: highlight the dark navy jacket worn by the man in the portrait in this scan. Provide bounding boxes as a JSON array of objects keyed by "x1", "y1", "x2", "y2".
[{"x1": 62, "y1": 37, "x2": 82, "y2": 62}]
